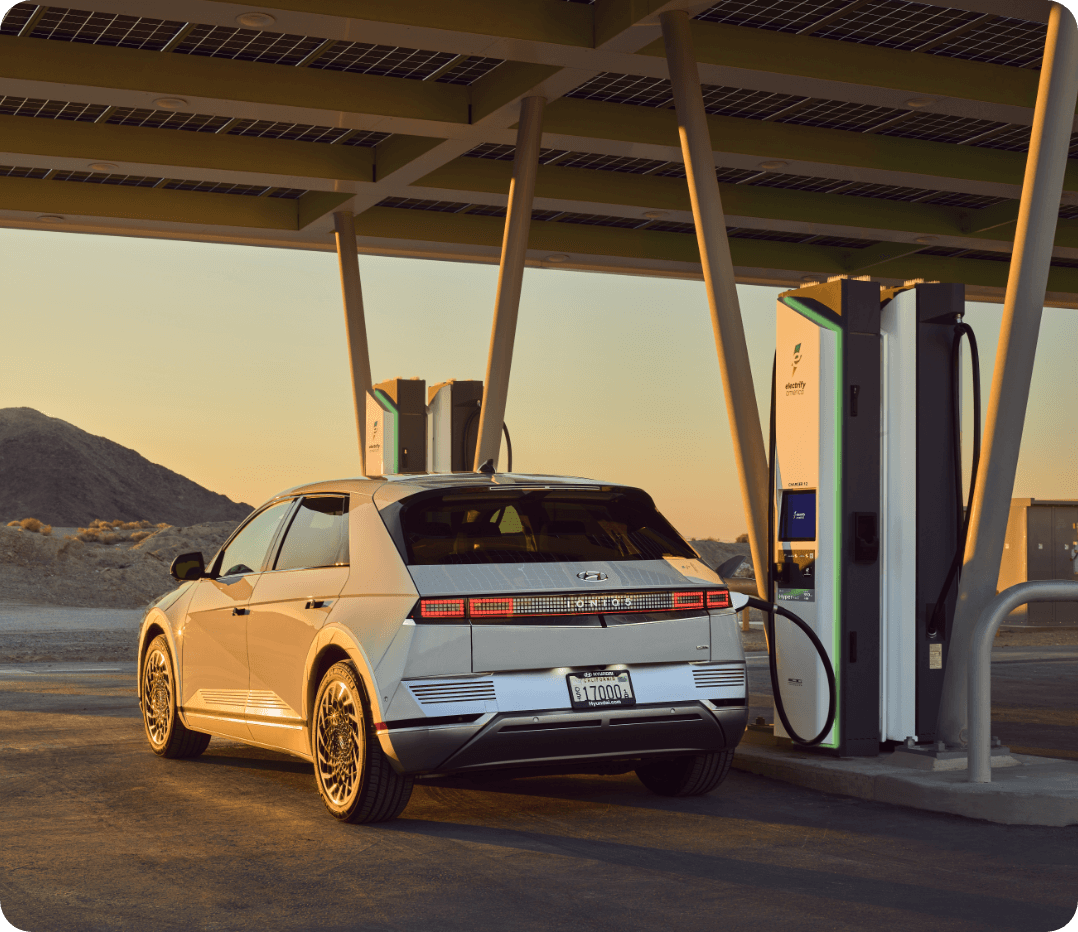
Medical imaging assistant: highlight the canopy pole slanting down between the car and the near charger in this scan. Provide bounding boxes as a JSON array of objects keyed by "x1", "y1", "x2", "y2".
[{"x1": 659, "y1": 10, "x2": 770, "y2": 601}]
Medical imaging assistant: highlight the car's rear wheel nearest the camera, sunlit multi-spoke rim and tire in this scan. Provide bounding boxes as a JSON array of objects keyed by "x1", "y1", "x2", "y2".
[{"x1": 310, "y1": 662, "x2": 413, "y2": 824}]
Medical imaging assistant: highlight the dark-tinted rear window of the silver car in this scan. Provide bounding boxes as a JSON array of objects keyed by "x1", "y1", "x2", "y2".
[{"x1": 400, "y1": 488, "x2": 696, "y2": 566}]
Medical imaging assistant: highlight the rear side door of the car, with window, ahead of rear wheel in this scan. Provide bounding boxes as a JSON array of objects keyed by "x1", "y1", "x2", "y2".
[{"x1": 246, "y1": 495, "x2": 348, "y2": 755}]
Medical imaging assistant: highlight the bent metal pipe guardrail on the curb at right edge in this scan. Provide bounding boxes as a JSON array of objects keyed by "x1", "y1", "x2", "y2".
[{"x1": 968, "y1": 580, "x2": 1078, "y2": 783}]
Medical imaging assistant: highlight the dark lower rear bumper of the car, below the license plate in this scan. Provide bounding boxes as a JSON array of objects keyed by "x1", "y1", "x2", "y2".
[{"x1": 388, "y1": 701, "x2": 748, "y2": 775}]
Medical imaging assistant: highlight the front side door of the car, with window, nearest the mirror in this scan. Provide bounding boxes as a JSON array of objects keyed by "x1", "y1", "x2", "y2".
[{"x1": 181, "y1": 500, "x2": 293, "y2": 739}]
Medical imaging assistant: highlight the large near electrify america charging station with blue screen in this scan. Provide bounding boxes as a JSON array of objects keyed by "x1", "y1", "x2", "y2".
[{"x1": 769, "y1": 278, "x2": 979, "y2": 756}]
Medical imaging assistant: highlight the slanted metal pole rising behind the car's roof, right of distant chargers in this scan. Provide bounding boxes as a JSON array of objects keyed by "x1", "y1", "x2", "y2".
[{"x1": 473, "y1": 97, "x2": 547, "y2": 470}]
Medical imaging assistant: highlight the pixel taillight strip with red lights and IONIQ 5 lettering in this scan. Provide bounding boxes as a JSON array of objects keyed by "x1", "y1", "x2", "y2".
[{"x1": 418, "y1": 588, "x2": 730, "y2": 621}]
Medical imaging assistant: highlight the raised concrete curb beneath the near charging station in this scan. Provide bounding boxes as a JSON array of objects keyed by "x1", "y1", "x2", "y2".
[{"x1": 733, "y1": 735, "x2": 1078, "y2": 826}]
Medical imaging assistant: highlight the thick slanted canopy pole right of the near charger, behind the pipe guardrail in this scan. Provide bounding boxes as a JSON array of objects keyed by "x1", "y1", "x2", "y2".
[{"x1": 938, "y1": 3, "x2": 1078, "y2": 746}]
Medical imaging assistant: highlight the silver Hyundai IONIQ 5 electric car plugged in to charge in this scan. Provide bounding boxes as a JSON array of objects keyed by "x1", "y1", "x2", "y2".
[{"x1": 138, "y1": 473, "x2": 747, "y2": 822}]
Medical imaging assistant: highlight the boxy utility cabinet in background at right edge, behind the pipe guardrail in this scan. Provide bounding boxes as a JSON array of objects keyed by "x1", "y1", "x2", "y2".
[{"x1": 998, "y1": 499, "x2": 1078, "y2": 625}]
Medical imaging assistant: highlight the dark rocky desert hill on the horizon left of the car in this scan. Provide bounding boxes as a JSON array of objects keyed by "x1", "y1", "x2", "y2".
[{"x1": 0, "y1": 407, "x2": 251, "y2": 527}]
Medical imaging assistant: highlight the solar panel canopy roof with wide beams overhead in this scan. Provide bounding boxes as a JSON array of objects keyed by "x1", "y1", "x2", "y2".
[{"x1": 0, "y1": 0, "x2": 1078, "y2": 307}]
